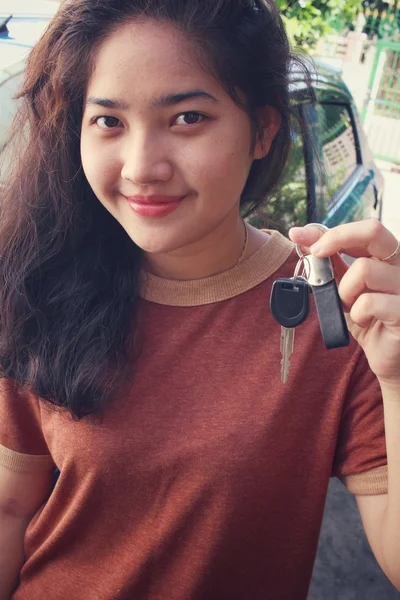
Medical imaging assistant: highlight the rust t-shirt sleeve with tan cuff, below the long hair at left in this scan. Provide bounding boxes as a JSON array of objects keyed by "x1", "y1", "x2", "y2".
[{"x1": 0, "y1": 377, "x2": 54, "y2": 471}]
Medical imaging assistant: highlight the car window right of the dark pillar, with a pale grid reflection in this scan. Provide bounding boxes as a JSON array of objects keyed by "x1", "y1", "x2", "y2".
[{"x1": 316, "y1": 104, "x2": 357, "y2": 208}]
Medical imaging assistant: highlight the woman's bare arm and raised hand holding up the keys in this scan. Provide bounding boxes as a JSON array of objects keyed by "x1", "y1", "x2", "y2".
[{"x1": 290, "y1": 219, "x2": 400, "y2": 591}]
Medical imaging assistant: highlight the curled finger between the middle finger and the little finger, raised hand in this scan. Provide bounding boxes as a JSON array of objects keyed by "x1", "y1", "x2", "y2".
[{"x1": 350, "y1": 293, "x2": 400, "y2": 328}]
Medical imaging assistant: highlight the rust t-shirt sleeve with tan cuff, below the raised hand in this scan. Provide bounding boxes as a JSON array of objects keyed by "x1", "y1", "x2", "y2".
[{"x1": 332, "y1": 347, "x2": 387, "y2": 495}]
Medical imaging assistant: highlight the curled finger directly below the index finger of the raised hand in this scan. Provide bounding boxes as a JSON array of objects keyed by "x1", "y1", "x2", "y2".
[{"x1": 339, "y1": 258, "x2": 400, "y2": 309}]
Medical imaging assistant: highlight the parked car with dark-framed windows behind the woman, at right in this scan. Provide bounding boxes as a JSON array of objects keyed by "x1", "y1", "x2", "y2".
[{"x1": 250, "y1": 60, "x2": 384, "y2": 230}]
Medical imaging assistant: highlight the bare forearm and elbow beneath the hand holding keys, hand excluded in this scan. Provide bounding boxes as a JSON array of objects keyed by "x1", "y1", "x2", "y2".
[{"x1": 356, "y1": 385, "x2": 400, "y2": 591}]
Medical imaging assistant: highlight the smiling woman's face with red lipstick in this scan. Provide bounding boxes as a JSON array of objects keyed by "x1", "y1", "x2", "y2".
[{"x1": 81, "y1": 21, "x2": 270, "y2": 253}]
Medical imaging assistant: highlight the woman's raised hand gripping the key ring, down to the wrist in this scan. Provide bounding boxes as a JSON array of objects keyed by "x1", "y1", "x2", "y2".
[{"x1": 289, "y1": 219, "x2": 400, "y2": 386}]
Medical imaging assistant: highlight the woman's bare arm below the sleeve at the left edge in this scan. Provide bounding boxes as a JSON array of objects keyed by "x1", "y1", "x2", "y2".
[{"x1": 0, "y1": 465, "x2": 53, "y2": 600}]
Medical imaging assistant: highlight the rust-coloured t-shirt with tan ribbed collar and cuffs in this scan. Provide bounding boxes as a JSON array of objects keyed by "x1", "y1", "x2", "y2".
[{"x1": 0, "y1": 233, "x2": 387, "y2": 600}]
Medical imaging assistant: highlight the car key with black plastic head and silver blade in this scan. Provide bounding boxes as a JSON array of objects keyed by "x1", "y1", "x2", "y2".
[{"x1": 270, "y1": 277, "x2": 310, "y2": 383}]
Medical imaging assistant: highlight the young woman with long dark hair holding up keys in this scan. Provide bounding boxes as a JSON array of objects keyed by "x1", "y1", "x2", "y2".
[{"x1": 0, "y1": 0, "x2": 400, "y2": 600}]
